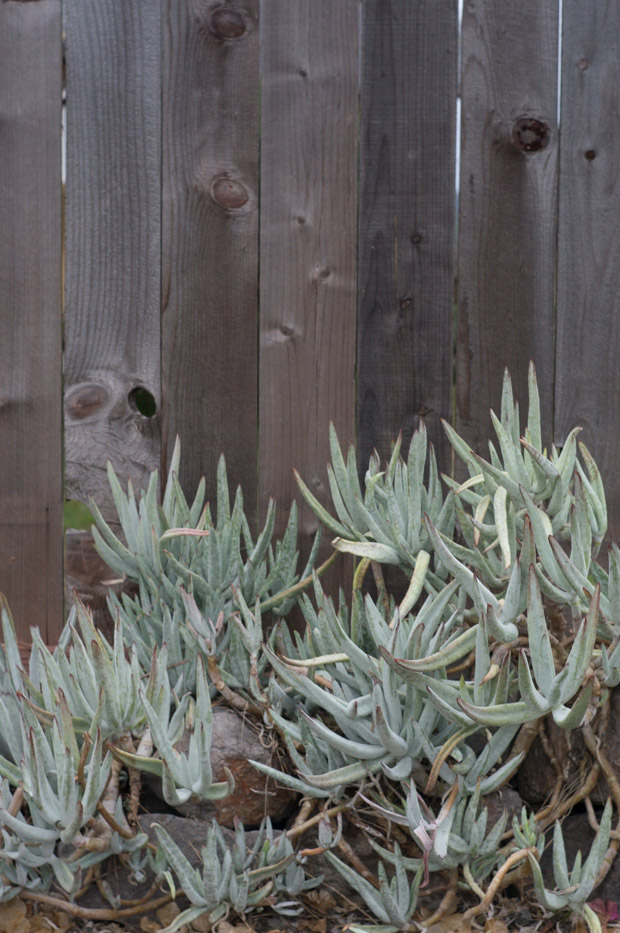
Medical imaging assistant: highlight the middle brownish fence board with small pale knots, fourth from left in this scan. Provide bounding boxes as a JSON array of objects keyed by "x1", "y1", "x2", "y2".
[{"x1": 259, "y1": 0, "x2": 359, "y2": 576}]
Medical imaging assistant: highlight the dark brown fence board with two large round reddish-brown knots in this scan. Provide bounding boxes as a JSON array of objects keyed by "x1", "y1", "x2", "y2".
[{"x1": 162, "y1": 0, "x2": 259, "y2": 517}]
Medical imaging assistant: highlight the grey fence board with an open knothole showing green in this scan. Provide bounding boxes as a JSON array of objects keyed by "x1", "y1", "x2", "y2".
[{"x1": 63, "y1": 0, "x2": 161, "y2": 515}]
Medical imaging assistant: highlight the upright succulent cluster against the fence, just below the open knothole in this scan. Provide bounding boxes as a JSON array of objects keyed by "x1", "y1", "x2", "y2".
[{"x1": 92, "y1": 441, "x2": 320, "y2": 693}]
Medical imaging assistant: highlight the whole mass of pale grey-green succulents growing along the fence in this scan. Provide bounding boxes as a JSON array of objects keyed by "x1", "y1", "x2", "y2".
[{"x1": 0, "y1": 367, "x2": 620, "y2": 933}]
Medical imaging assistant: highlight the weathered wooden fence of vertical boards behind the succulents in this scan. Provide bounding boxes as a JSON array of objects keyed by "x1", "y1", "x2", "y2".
[{"x1": 0, "y1": 0, "x2": 620, "y2": 641}]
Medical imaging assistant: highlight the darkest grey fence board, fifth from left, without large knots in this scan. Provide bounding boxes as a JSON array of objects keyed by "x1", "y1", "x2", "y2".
[{"x1": 358, "y1": 0, "x2": 457, "y2": 471}]
